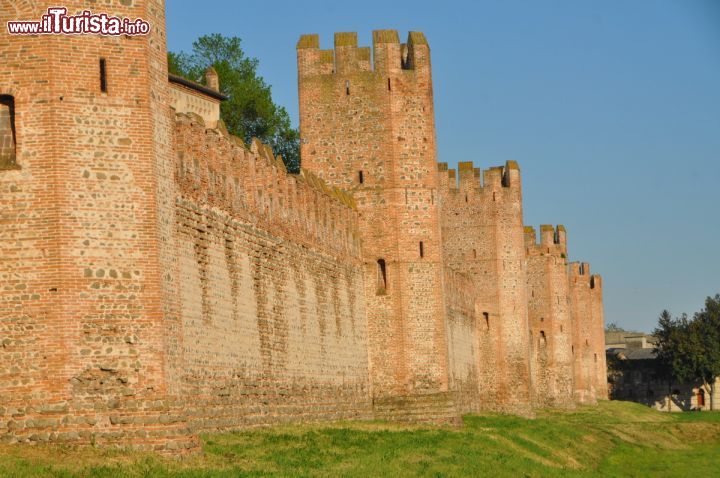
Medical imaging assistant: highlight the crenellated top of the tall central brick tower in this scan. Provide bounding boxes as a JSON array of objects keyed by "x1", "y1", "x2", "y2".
[{"x1": 297, "y1": 30, "x2": 430, "y2": 78}]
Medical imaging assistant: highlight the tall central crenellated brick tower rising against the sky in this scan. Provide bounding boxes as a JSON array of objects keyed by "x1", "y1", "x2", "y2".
[{"x1": 297, "y1": 30, "x2": 448, "y2": 397}]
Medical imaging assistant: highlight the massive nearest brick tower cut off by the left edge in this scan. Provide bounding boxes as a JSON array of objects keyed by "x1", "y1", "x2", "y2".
[{"x1": 0, "y1": 0, "x2": 191, "y2": 446}]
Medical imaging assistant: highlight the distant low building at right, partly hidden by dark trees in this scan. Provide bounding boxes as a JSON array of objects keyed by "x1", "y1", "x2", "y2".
[{"x1": 605, "y1": 330, "x2": 720, "y2": 412}]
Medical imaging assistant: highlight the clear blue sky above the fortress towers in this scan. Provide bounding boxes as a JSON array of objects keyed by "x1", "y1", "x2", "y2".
[{"x1": 167, "y1": 0, "x2": 720, "y2": 331}]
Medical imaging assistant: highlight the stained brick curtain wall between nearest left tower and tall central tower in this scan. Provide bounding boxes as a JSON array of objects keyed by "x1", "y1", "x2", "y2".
[{"x1": 175, "y1": 115, "x2": 371, "y2": 430}]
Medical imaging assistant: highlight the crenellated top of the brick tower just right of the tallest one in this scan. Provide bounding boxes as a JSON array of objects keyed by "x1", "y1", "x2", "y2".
[{"x1": 437, "y1": 161, "x2": 520, "y2": 195}]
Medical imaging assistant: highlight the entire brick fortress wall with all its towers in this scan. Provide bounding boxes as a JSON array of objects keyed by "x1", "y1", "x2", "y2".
[{"x1": 0, "y1": 0, "x2": 607, "y2": 452}]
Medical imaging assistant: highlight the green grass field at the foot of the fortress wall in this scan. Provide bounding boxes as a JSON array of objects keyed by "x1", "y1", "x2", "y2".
[{"x1": 0, "y1": 402, "x2": 720, "y2": 478}]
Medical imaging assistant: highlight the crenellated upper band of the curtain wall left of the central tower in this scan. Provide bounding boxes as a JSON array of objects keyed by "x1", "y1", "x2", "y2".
[{"x1": 175, "y1": 114, "x2": 360, "y2": 256}]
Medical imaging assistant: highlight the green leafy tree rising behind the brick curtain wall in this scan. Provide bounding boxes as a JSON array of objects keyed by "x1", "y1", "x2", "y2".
[{"x1": 168, "y1": 33, "x2": 300, "y2": 173}]
